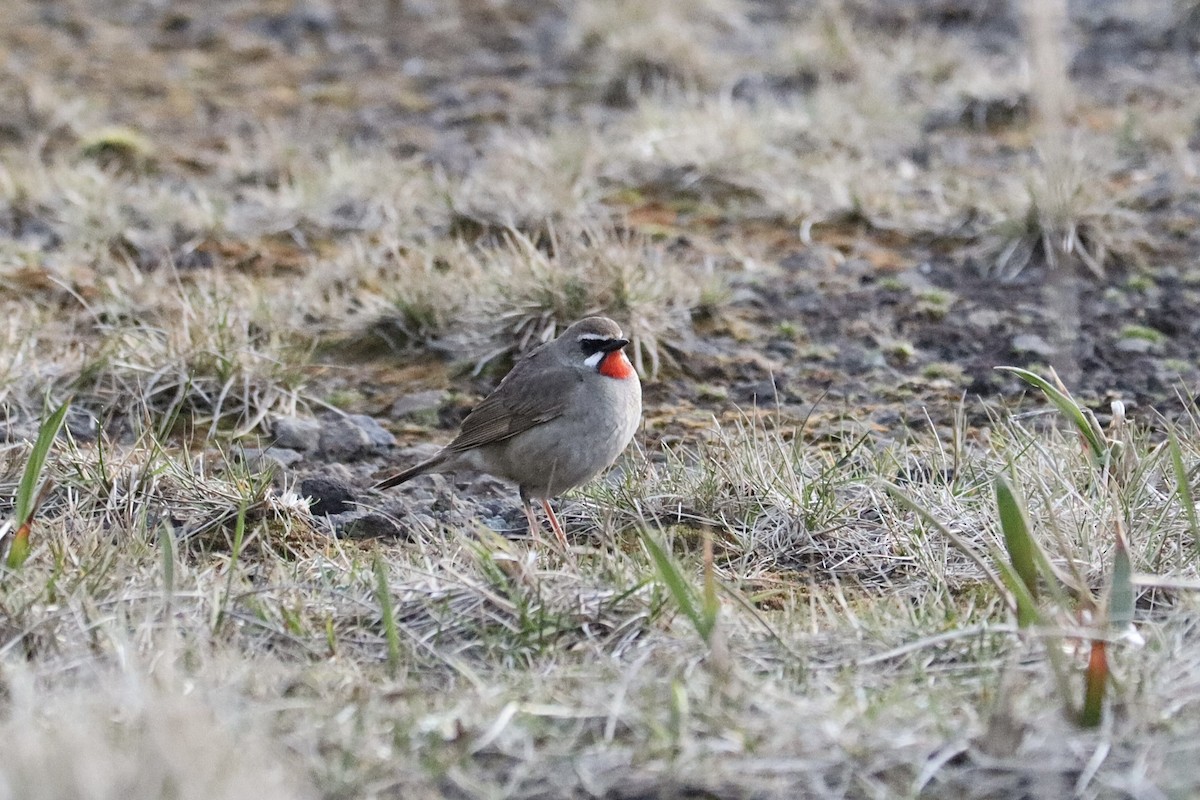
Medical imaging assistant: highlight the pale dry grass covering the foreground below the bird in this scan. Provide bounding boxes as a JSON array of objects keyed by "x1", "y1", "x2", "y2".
[{"x1": 4, "y1": 400, "x2": 1200, "y2": 796}]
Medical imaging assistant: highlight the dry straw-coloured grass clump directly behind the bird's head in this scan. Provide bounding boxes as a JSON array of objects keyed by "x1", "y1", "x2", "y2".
[{"x1": 343, "y1": 227, "x2": 705, "y2": 377}]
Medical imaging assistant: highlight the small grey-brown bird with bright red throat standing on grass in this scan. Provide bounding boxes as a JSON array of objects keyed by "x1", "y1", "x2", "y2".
[{"x1": 376, "y1": 317, "x2": 642, "y2": 551}]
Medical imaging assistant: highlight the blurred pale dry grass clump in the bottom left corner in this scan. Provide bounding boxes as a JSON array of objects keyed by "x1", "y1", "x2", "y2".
[{"x1": 0, "y1": 666, "x2": 318, "y2": 800}]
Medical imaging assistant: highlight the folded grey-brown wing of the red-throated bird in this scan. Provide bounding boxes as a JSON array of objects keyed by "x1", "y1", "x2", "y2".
[{"x1": 446, "y1": 354, "x2": 578, "y2": 452}]
